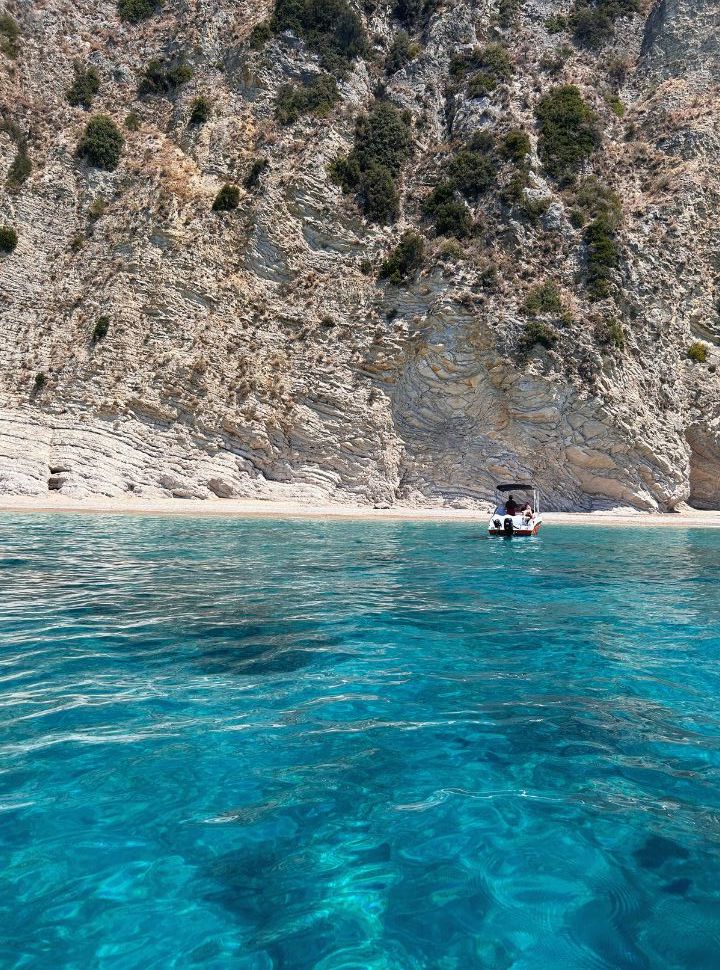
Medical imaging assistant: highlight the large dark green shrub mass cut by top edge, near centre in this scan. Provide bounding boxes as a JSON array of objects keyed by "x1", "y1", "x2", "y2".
[{"x1": 270, "y1": 0, "x2": 368, "y2": 71}]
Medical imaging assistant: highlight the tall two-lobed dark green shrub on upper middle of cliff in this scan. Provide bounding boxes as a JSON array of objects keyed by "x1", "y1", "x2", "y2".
[{"x1": 331, "y1": 101, "x2": 412, "y2": 222}]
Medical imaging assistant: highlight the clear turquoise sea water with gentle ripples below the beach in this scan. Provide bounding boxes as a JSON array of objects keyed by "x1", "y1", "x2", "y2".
[{"x1": 0, "y1": 515, "x2": 720, "y2": 970}]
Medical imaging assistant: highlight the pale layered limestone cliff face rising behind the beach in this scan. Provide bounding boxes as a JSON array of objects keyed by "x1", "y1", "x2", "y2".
[{"x1": 0, "y1": 0, "x2": 720, "y2": 510}]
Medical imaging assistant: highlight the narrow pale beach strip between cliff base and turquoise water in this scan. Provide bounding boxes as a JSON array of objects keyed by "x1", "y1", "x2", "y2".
[{"x1": 0, "y1": 494, "x2": 720, "y2": 529}]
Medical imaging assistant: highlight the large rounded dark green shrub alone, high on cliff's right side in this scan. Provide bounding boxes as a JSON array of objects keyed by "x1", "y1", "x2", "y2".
[{"x1": 535, "y1": 84, "x2": 600, "y2": 183}]
